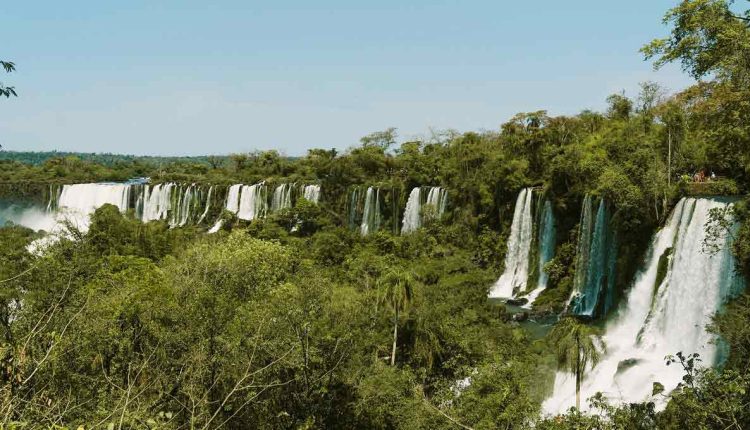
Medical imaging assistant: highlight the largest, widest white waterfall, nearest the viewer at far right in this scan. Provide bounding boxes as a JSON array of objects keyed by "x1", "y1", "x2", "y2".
[{"x1": 543, "y1": 198, "x2": 744, "y2": 414}]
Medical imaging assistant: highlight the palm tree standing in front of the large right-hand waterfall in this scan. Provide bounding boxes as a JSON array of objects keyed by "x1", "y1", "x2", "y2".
[{"x1": 549, "y1": 317, "x2": 603, "y2": 410}]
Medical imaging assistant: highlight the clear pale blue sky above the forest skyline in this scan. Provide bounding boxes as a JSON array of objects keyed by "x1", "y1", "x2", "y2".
[{"x1": 0, "y1": 0, "x2": 691, "y2": 155}]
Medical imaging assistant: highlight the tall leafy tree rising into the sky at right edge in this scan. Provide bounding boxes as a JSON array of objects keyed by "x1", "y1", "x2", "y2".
[{"x1": 641, "y1": 0, "x2": 750, "y2": 178}]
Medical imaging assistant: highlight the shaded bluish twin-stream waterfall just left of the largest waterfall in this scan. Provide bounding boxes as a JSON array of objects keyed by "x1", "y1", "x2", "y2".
[{"x1": 569, "y1": 195, "x2": 617, "y2": 317}]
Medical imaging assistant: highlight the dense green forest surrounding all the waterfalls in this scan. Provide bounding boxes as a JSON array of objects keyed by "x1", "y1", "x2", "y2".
[{"x1": 0, "y1": 0, "x2": 750, "y2": 430}]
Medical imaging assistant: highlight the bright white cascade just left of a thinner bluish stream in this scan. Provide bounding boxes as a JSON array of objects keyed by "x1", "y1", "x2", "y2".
[{"x1": 489, "y1": 188, "x2": 534, "y2": 298}]
